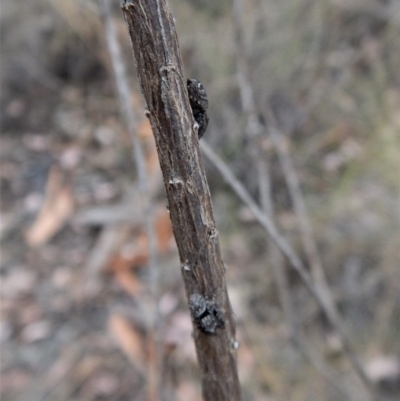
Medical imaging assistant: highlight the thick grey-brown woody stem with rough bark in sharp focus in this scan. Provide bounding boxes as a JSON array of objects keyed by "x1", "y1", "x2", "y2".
[{"x1": 122, "y1": 0, "x2": 241, "y2": 401}]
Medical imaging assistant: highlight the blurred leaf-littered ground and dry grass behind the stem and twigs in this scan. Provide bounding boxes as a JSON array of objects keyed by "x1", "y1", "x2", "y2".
[{"x1": 0, "y1": 0, "x2": 400, "y2": 401}]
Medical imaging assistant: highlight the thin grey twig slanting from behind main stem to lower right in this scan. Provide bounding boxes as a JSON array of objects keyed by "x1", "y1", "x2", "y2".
[{"x1": 200, "y1": 142, "x2": 373, "y2": 393}]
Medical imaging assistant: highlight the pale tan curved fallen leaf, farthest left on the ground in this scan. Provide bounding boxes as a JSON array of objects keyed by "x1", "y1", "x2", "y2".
[{"x1": 25, "y1": 166, "x2": 74, "y2": 247}]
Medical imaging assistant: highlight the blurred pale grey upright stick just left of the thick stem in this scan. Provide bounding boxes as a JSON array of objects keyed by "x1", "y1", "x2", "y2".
[{"x1": 101, "y1": 0, "x2": 162, "y2": 401}]
